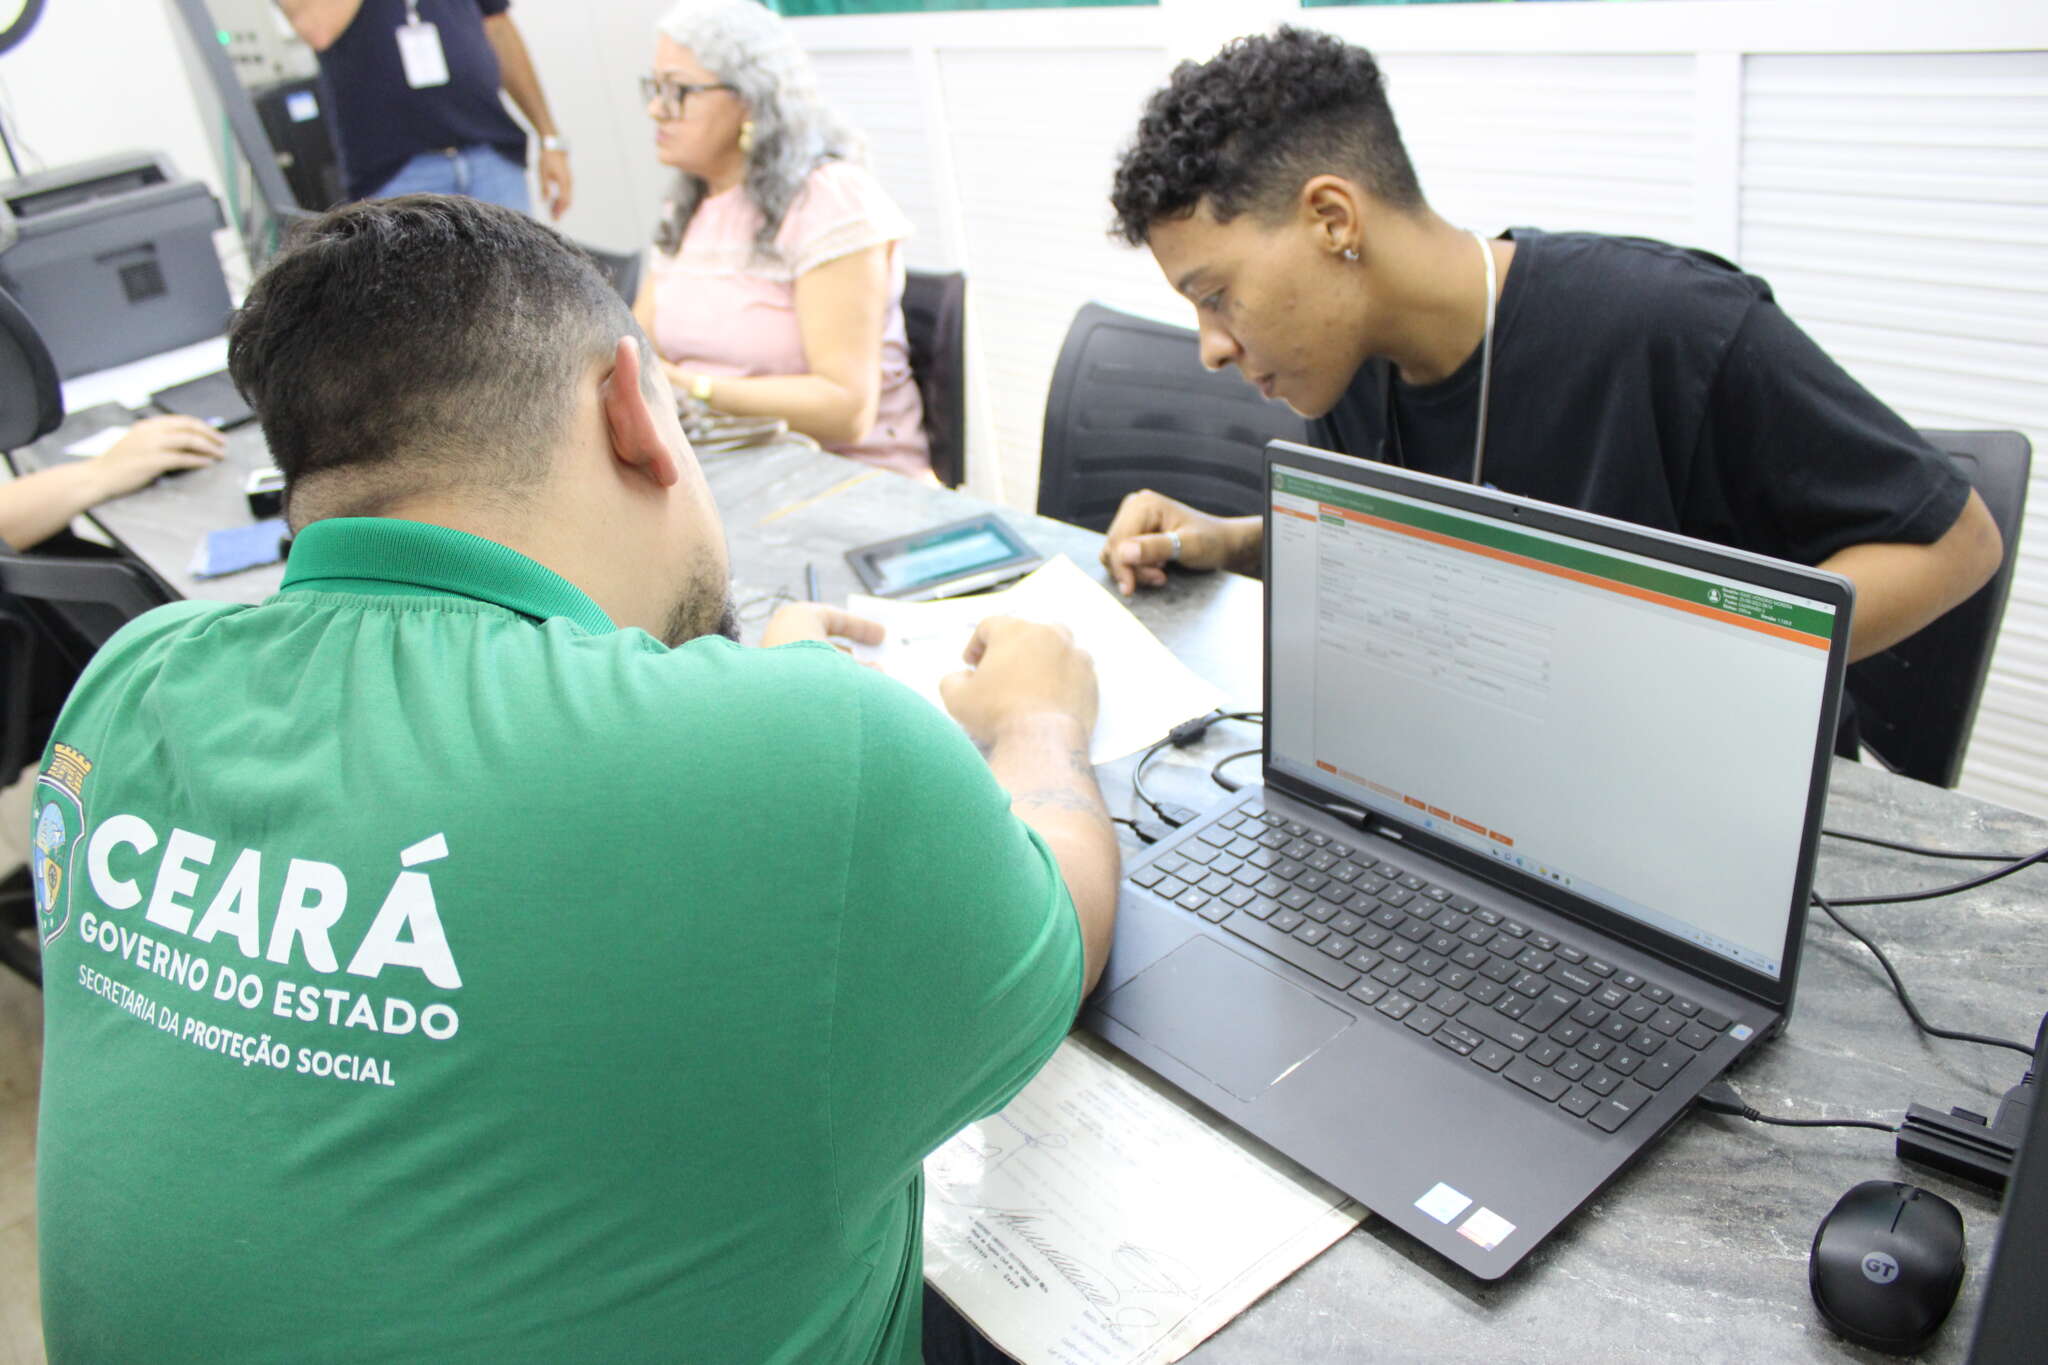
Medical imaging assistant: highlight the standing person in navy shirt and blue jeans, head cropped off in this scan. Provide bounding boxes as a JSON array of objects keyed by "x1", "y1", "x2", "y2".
[{"x1": 276, "y1": 0, "x2": 571, "y2": 219}]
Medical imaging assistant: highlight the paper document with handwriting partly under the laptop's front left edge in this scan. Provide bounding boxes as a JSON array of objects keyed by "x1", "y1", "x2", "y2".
[{"x1": 924, "y1": 1033, "x2": 1366, "y2": 1365}]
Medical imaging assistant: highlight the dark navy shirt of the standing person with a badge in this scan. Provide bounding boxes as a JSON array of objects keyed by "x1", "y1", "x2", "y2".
[{"x1": 319, "y1": 0, "x2": 526, "y2": 199}]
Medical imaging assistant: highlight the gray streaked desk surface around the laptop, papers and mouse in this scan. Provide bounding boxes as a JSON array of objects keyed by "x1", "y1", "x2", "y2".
[{"x1": 27, "y1": 421, "x2": 2048, "y2": 1365}]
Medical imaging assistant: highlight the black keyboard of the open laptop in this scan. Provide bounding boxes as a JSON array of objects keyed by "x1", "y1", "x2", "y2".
[{"x1": 1130, "y1": 792, "x2": 1733, "y2": 1134}]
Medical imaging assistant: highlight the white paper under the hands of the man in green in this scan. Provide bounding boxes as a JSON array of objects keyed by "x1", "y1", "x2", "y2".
[{"x1": 846, "y1": 555, "x2": 1225, "y2": 763}]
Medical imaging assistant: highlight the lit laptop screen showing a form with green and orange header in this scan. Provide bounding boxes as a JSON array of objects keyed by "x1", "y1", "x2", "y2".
[{"x1": 1266, "y1": 454, "x2": 1835, "y2": 980}]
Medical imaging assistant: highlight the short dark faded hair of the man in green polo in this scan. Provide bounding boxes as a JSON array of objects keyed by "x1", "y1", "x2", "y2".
[{"x1": 227, "y1": 194, "x2": 639, "y2": 524}]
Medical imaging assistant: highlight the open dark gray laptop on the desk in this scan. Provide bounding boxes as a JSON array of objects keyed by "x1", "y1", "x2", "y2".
[{"x1": 1081, "y1": 442, "x2": 1853, "y2": 1279}]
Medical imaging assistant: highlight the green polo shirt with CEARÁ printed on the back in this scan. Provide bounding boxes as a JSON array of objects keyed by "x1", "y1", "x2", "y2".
[{"x1": 31, "y1": 520, "x2": 1083, "y2": 1365}]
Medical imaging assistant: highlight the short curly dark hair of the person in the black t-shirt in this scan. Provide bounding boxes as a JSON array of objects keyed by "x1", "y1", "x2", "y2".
[{"x1": 1110, "y1": 27, "x2": 1423, "y2": 246}]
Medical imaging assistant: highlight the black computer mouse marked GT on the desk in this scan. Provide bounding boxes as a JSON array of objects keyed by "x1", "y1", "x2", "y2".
[{"x1": 1806, "y1": 1181, "x2": 1962, "y2": 1355}]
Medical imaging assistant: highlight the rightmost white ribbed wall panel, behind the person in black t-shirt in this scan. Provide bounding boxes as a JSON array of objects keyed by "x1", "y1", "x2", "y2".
[{"x1": 1741, "y1": 51, "x2": 2048, "y2": 810}]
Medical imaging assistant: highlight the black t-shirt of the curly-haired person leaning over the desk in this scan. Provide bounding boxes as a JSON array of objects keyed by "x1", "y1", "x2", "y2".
[{"x1": 1311, "y1": 227, "x2": 1970, "y2": 565}]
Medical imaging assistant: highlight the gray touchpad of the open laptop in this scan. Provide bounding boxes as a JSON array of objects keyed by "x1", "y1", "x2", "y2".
[{"x1": 1102, "y1": 937, "x2": 1352, "y2": 1101}]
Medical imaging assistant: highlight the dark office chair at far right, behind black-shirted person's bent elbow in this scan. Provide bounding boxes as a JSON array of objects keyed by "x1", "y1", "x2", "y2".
[{"x1": 1845, "y1": 432, "x2": 2034, "y2": 788}]
